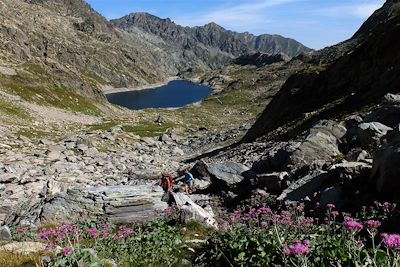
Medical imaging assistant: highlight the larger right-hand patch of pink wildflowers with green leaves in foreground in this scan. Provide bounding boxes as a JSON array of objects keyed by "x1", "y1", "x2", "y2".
[{"x1": 197, "y1": 202, "x2": 400, "y2": 266}]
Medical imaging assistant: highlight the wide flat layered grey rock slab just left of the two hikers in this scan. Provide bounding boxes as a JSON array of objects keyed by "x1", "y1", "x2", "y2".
[{"x1": 41, "y1": 184, "x2": 168, "y2": 223}]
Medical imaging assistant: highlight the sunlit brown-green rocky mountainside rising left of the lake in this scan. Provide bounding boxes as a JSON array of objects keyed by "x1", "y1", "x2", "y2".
[{"x1": 0, "y1": 0, "x2": 175, "y2": 97}]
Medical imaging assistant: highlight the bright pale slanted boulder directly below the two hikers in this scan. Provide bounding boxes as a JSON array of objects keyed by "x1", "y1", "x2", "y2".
[{"x1": 172, "y1": 193, "x2": 218, "y2": 229}]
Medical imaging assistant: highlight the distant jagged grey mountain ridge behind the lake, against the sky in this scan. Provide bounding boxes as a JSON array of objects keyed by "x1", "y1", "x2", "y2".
[{"x1": 111, "y1": 13, "x2": 310, "y2": 68}]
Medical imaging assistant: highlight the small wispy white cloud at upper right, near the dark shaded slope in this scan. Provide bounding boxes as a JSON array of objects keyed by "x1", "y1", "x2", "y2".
[{"x1": 318, "y1": 0, "x2": 385, "y2": 19}]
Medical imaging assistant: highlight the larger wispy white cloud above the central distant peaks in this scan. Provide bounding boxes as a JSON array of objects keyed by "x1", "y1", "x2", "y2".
[{"x1": 175, "y1": 0, "x2": 302, "y2": 29}]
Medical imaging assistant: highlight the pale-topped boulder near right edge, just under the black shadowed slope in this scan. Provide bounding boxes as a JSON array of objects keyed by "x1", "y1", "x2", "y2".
[{"x1": 357, "y1": 122, "x2": 393, "y2": 147}]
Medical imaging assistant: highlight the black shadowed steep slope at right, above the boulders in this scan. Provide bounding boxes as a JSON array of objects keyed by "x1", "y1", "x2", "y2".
[{"x1": 244, "y1": 1, "x2": 400, "y2": 142}]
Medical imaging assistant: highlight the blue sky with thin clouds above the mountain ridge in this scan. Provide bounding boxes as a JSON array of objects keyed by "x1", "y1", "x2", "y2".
[{"x1": 86, "y1": 0, "x2": 385, "y2": 49}]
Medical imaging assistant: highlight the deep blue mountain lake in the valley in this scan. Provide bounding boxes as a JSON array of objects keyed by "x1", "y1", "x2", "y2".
[{"x1": 106, "y1": 80, "x2": 212, "y2": 110}]
